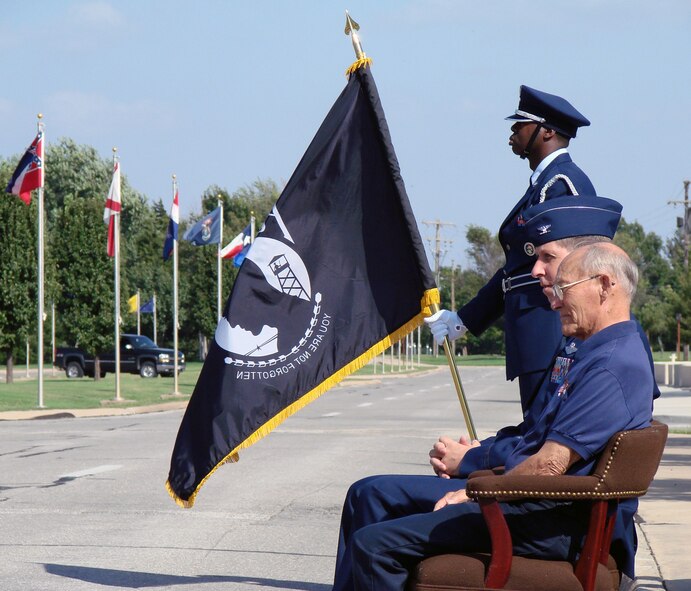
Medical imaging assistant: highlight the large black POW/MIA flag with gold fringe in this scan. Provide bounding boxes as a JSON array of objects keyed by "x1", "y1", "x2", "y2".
[{"x1": 166, "y1": 59, "x2": 439, "y2": 507}]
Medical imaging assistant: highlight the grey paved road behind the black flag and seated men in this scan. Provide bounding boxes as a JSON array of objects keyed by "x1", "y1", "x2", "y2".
[{"x1": 0, "y1": 368, "x2": 520, "y2": 591}]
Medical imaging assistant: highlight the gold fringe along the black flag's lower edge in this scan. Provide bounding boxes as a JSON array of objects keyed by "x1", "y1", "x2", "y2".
[{"x1": 166, "y1": 286, "x2": 440, "y2": 509}]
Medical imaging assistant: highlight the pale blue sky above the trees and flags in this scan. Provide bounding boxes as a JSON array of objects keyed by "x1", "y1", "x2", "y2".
[{"x1": 0, "y1": 0, "x2": 691, "y2": 264}]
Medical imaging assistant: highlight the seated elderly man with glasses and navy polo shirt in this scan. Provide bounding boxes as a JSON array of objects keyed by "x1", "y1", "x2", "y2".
[{"x1": 352, "y1": 244, "x2": 653, "y2": 591}]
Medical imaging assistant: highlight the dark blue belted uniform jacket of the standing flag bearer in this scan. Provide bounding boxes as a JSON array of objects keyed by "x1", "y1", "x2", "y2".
[{"x1": 458, "y1": 153, "x2": 595, "y2": 380}]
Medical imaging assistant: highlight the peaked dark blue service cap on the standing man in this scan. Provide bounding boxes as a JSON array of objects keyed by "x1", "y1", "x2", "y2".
[{"x1": 506, "y1": 86, "x2": 590, "y2": 137}]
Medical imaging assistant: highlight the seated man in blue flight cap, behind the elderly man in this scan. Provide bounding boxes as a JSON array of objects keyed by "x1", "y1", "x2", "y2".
[{"x1": 334, "y1": 196, "x2": 659, "y2": 591}]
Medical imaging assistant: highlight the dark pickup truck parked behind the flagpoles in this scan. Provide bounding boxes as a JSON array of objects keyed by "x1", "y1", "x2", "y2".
[{"x1": 55, "y1": 334, "x2": 185, "y2": 378}]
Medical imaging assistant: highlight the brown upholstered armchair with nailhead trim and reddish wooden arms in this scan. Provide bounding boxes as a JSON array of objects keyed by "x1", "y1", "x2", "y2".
[{"x1": 408, "y1": 421, "x2": 667, "y2": 591}]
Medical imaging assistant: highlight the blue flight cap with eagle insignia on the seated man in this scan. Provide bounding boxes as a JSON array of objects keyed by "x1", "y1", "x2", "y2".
[{"x1": 520, "y1": 195, "x2": 622, "y2": 250}]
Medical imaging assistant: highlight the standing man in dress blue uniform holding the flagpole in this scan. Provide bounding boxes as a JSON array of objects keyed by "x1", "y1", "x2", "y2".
[{"x1": 426, "y1": 86, "x2": 596, "y2": 410}]
